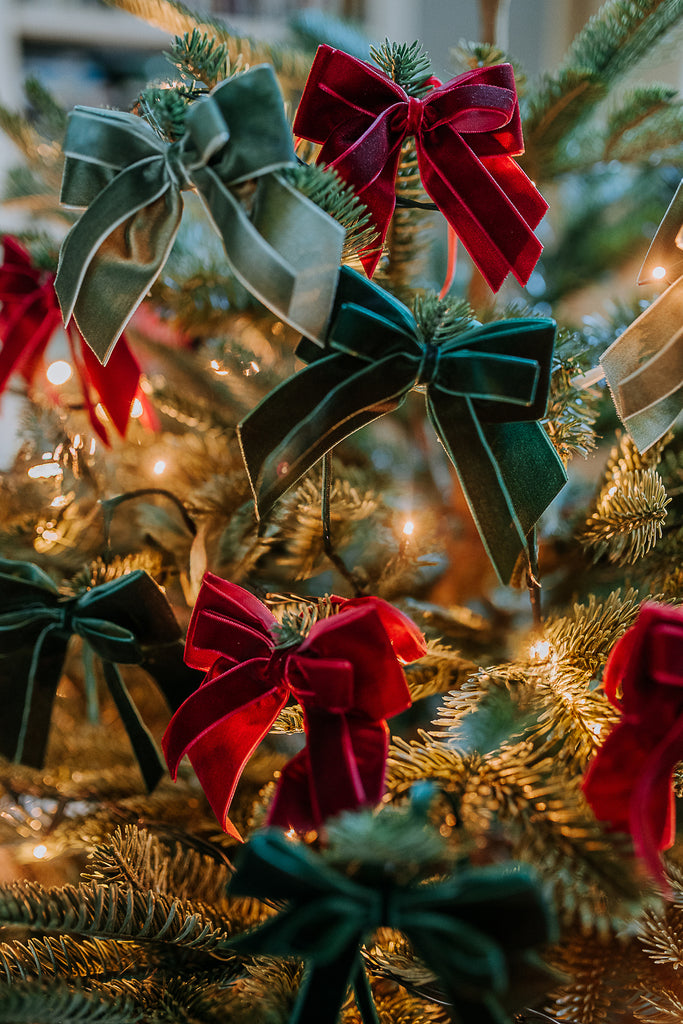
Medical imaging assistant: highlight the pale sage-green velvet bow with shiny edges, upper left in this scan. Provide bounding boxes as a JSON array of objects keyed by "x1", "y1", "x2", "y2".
[{"x1": 55, "y1": 65, "x2": 344, "y2": 362}]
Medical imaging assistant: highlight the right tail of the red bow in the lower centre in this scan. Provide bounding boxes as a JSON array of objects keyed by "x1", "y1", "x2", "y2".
[{"x1": 268, "y1": 709, "x2": 389, "y2": 833}]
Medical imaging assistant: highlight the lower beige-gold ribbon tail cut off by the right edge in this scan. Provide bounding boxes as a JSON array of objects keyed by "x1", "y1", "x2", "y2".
[{"x1": 600, "y1": 276, "x2": 683, "y2": 452}]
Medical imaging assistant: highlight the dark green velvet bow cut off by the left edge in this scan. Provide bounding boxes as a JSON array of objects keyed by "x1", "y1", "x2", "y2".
[{"x1": 0, "y1": 558, "x2": 201, "y2": 790}]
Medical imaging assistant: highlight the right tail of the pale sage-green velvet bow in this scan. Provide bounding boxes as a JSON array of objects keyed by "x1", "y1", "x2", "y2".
[{"x1": 195, "y1": 168, "x2": 344, "y2": 338}]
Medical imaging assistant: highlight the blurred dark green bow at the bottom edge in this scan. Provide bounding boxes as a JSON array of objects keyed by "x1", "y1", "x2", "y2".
[{"x1": 229, "y1": 830, "x2": 553, "y2": 1024}]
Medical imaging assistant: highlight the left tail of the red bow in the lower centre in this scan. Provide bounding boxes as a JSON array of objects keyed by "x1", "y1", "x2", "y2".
[{"x1": 162, "y1": 659, "x2": 288, "y2": 839}]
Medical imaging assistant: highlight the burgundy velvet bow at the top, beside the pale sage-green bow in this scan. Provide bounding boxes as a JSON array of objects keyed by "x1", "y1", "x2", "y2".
[{"x1": 294, "y1": 46, "x2": 548, "y2": 291}]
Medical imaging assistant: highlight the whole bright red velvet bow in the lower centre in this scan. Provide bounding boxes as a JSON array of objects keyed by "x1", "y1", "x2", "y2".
[{"x1": 162, "y1": 572, "x2": 426, "y2": 839}]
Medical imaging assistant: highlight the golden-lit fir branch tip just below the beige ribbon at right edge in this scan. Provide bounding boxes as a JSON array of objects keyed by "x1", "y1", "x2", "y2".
[{"x1": 582, "y1": 469, "x2": 671, "y2": 565}]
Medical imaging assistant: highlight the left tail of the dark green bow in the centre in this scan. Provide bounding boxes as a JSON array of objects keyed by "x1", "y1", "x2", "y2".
[{"x1": 238, "y1": 354, "x2": 410, "y2": 518}]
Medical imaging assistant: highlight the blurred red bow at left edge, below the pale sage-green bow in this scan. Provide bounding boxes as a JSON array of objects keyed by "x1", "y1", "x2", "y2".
[{"x1": 0, "y1": 236, "x2": 140, "y2": 443}]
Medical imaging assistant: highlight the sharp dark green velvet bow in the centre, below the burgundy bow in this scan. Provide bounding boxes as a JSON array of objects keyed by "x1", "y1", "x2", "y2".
[{"x1": 238, "y1": 267, "x2": 566, "y2": 581}]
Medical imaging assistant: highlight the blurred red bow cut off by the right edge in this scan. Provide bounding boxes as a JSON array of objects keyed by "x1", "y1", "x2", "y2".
[{"x1": 584, "y1": 603, "x2": 683, "y2": 883}]
